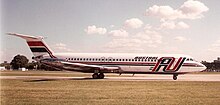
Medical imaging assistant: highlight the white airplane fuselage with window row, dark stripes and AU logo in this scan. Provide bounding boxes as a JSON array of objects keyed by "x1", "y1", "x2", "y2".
[{"x1": 45, "y1": 53, "x2": 206, "y2": 74}]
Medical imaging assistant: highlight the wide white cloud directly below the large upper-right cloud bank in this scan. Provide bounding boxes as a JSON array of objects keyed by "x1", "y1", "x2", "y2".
[{"x1": 160, "y1": 21, "x2": 189, "y2": 29}]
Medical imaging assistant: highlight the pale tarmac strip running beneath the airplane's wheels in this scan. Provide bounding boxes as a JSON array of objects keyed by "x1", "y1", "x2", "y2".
[{"x1": 0, "y1": 74, "x2": 220, "y2": 81}]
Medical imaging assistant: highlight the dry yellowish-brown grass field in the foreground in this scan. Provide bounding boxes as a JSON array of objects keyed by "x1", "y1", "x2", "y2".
[{"x1": 1, "y1": 72, "x2": 220, "y2": 105}]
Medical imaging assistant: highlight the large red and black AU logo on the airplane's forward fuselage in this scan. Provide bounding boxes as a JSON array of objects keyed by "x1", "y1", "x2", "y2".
[{"x1": 152, "y1": 57, "x2": 186, "y2": 72}]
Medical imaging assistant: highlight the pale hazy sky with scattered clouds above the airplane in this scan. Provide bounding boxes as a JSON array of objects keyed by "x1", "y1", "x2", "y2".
[{"x1": 0, "y1": 0, "x2": 220, "y2": 62}]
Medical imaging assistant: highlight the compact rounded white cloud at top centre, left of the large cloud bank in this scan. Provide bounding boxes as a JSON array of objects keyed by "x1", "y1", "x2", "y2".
[{"x1": 124, "y1": 18, "x2": 143, "y2": 28}]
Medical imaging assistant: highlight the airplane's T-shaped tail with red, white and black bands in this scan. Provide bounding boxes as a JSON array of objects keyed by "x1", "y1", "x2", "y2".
[{"x1": 8, "y1": 33, "x2": 56, "y2": 60}]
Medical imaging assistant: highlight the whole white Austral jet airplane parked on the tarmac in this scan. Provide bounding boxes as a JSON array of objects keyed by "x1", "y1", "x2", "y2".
[{"x1": 8, "y1": 33, "x2": 206, "y2": 80}]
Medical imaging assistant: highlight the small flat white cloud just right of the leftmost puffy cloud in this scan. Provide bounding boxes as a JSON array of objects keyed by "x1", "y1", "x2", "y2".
[{"x1": 109, "y1": 29, "x2": 128, "y2": 37}]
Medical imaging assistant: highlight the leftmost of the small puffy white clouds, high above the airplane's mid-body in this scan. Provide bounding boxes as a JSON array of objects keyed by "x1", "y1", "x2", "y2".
[{"x1": 85, "y1": 25, "x2": 107, "y2": 35}]
